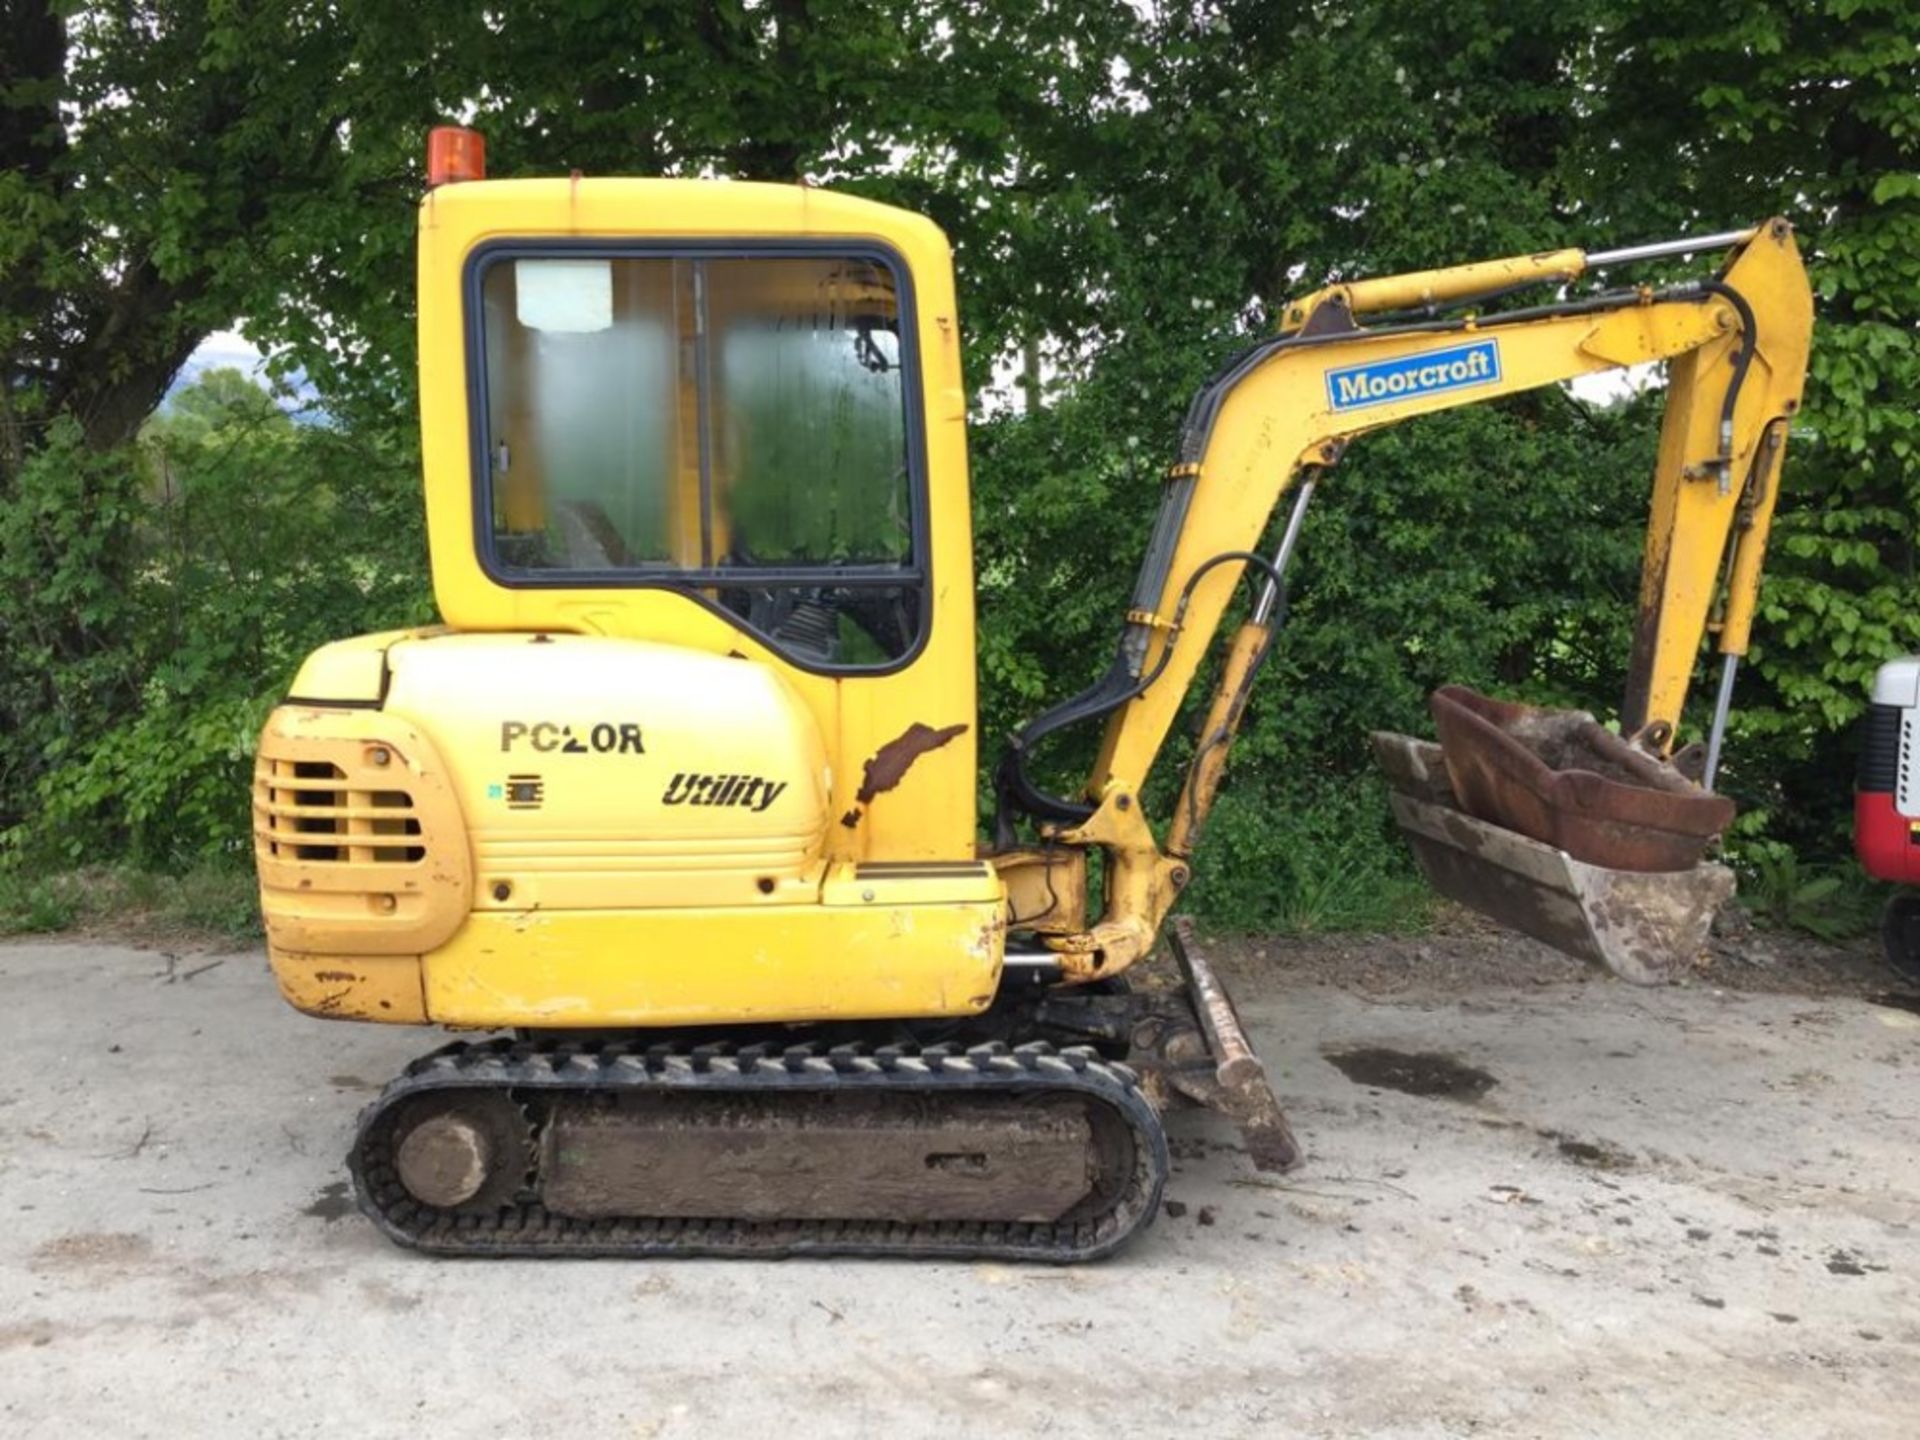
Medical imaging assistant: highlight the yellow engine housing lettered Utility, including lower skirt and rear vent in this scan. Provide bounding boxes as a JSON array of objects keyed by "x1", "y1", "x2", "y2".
[{"x1": 253, "y1": 634, "x2": 1004, "y2": 1027}]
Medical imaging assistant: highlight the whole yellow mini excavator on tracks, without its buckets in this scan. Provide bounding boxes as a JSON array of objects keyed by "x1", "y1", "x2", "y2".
[{"x1": 253, "y1": 129, "x2": 1811, "y2": 1260}]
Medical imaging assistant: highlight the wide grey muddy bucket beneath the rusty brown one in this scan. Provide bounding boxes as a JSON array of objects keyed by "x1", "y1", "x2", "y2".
[{"x1": 1373, "y1": 732, "x2": 1734, "y2": 985}]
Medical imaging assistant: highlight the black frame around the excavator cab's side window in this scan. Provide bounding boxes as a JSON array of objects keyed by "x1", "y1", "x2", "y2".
[{"x1": 461, "y1": 236, "x2": 933, "y2": 676}]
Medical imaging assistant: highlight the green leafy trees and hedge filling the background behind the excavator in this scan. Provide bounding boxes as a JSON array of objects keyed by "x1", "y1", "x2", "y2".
[{"x1": 0, "y1": 0, "x2": 1920, "y2": 948}]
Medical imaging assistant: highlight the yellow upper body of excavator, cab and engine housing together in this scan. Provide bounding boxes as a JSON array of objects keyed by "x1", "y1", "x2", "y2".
[{"x1": 261, "y1": 168, "x2": 1004, "y2": 1027}]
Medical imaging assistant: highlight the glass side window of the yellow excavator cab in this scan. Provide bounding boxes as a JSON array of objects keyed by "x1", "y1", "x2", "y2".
[{"x1": 480, "y1": 255, "x2": 922, "y2": 664}]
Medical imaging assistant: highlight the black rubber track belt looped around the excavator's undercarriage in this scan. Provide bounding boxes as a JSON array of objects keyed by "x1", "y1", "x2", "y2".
[{"x1": 348, "y1": 1041, "x2": 1167, "y2": 1263}]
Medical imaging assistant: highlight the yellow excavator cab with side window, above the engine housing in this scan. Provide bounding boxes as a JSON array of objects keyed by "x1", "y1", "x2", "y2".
[{"x1": 420, "y1": 180, "x2": 977, "y2": 860}]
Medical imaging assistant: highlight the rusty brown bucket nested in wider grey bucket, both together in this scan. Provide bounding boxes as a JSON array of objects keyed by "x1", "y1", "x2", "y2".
[{"x1": 1373, "y1": 706, "x2": 1734, "y2": 985}]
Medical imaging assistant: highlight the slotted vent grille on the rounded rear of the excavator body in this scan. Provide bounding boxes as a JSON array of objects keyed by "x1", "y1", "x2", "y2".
[{"x1": 253, "y1": 756, "x2": 426, "y2": 864}]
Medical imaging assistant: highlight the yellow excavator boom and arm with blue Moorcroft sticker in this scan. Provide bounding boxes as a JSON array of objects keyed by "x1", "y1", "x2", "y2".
[{"x1": 998, "y1": 219, "x2": 1812, "y2": 979}]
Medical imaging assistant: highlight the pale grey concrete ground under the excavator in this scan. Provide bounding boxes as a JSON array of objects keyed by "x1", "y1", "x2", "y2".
[{"x1": 0, "y1": 945, "x2": 1920, "y2": 1438}]
